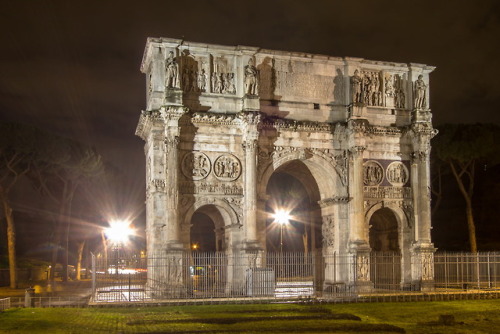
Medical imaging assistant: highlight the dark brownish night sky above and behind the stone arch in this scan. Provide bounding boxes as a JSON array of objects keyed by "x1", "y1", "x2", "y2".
[{"x1": 0, "y1": 0, "x2": 500, "y2": 252}]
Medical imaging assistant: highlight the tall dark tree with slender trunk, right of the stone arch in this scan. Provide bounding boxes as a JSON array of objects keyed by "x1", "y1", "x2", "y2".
[{"x1": 433, "y1": 124, "x2": 500, "y2": 253}]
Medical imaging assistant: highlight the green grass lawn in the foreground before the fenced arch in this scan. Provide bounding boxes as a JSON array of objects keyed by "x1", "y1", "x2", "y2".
[{"x1": 0, "y1": 300, "x2": 500, "y2": 334}]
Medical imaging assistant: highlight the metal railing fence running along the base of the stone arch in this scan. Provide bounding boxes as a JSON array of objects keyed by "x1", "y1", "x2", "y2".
[{"x1": 91, "y1": 252, "x2": 500, "y2": 303}]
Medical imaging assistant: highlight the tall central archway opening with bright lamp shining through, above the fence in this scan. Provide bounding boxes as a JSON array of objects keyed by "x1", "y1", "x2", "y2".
[{"x1": 266, "y1": 160, "x2": 322, "y2": 253}]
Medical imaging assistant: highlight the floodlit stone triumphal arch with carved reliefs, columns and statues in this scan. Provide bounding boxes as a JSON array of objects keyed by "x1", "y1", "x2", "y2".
[{"x1": 136, "y1": 38, "x2": 435, "y2": 289}]
